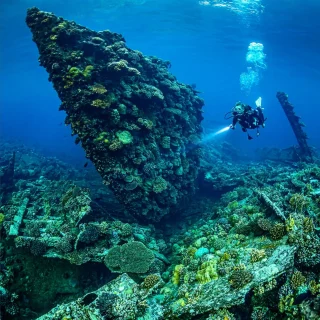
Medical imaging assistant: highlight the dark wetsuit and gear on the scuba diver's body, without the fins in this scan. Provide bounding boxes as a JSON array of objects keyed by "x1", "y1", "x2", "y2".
[{"x1": 232, "y1": 105, "x2": 265, "y2": 139}]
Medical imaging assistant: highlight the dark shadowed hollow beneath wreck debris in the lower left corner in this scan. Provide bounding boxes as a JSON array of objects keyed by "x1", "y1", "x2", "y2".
[{"x1": 1, "y1": 243, "x2": 114, "y2": 319}]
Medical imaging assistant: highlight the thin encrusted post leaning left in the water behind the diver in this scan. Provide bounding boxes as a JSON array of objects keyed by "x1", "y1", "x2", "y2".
[{"x1": 277, "y1": 92, "x2": 313, "y2": 162}]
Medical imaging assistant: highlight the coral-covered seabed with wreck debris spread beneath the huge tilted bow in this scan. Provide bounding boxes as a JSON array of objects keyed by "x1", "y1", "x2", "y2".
[{"x1": 0, "y1": 134, "x2": 320, "y2": 319}]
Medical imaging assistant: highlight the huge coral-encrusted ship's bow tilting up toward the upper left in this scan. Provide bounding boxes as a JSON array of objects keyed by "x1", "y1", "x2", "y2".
[{"x1": 26, "y1": 8, "x2": 204, "y2": 221}]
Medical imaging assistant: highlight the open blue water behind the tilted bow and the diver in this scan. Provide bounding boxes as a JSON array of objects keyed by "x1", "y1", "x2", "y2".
[{"x1": 0, "y1": 0, "x2": 320, "y2": 162}]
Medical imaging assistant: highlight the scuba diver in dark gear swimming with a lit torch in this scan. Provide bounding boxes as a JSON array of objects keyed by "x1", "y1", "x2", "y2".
[{"x1": 225, "y1": 97, "x2": 267, "y2": 140}]
